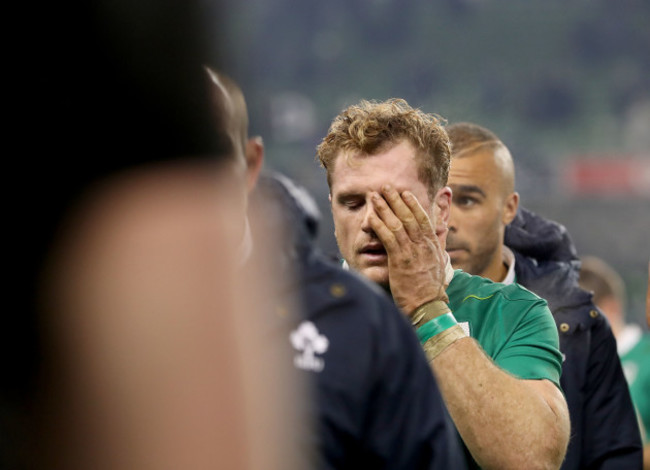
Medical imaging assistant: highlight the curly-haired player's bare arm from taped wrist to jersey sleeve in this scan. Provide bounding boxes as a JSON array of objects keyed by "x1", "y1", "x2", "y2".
[{"x1": 432, "y1": 338, "x2": 570, "y2": 469}]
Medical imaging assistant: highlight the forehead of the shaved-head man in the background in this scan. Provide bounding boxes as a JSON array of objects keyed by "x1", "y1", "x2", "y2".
[{"x1": 449, "y1": 147, "x2": 504, "y2": 192}]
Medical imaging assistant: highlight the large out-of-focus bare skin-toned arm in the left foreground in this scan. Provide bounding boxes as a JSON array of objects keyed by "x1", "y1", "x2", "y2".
[{"x1": 37, "y1": 160, "x2": 302, "y2": 470}]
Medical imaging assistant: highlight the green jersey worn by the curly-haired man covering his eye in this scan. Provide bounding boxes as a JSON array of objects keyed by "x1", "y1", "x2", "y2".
[{"x1": 447, "y1": 269, "x2": 562, "y2": 390}]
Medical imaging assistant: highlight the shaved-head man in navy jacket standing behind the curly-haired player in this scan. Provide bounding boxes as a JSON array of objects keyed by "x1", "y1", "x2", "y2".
[{"x1": 447, "y1": 123, "x2": 641, "y2": 469}]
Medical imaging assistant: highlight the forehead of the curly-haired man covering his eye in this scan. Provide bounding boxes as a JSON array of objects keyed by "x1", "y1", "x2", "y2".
[{"x1": 331, "y1": 141, "x2": 427, "y2": 198}]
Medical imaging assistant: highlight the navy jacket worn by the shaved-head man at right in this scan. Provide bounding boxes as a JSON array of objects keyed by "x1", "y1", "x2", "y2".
[{"x1": 505, "y1": 208, "x2": 642, "y2": 470}]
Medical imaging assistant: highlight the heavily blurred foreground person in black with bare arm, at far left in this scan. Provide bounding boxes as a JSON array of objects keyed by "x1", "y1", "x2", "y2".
[{"x1": 5, "y1": 0, "x2": 304, "y2": 470}]
